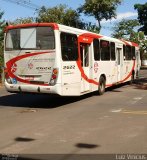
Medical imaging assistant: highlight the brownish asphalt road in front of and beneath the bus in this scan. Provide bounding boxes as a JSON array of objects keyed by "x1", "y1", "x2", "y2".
[{"x1": 0, "y1": 70, "x2": 147, "y2": 159}]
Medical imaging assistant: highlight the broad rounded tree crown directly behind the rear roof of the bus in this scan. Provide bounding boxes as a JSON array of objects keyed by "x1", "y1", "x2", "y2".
[{"x1": 36, "y1": 5, "x2": 84, "y2": 28}]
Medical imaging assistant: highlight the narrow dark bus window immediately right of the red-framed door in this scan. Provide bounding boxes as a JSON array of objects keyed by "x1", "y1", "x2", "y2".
[{"x1": 93, "y1": 39, "x2": 100, "y2": 61}]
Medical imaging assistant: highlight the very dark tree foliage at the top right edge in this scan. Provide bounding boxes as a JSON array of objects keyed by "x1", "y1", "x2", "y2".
[{"x1": 134, "y1": 3, "x2": 147, "y2": 35}]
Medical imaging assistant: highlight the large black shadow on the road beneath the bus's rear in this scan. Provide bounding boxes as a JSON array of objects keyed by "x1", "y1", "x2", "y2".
[{"x1": 0, "y1": 93, "x2": 92, "y2": 109}]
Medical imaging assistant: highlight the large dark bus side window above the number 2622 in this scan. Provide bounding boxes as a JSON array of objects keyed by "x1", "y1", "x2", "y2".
[{"x1": 60, "y1": 32, "x2": 78, "y2": 61}]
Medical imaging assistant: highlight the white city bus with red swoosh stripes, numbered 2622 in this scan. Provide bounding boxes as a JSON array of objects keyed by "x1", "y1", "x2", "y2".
[{"x1": 4, "y1": 23, "x2": 141, "y2": 96}]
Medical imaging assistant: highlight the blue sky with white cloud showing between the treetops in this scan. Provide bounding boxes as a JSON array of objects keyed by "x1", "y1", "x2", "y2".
[{"x1": 0, "y1": 0, "x2": 147, "y2": 36}]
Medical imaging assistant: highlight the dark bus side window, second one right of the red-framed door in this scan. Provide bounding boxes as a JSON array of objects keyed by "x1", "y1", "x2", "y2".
[{"x1": 100, "y1": 40, "x2": 110, "y2": 61}]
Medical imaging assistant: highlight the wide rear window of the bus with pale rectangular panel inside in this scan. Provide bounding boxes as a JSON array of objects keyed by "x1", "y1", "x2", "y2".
[{"x1": 5, "y1": 27, "x2": 55, "y2": 51}]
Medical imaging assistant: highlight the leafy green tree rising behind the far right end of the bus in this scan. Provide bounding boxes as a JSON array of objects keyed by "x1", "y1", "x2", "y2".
[{"x1": 112, "y1": 19, "x2": 139, "y2": 42}]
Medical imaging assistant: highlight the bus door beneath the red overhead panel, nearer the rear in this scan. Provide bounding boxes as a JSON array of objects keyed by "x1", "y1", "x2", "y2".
[{"x1": 80, "y1": 43, "x2": 90, "y2": 92}]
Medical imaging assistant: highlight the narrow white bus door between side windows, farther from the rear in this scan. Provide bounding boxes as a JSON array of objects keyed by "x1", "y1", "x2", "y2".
[{"x1": 116, "y1": 48, "x2": 123, "y2": 82}]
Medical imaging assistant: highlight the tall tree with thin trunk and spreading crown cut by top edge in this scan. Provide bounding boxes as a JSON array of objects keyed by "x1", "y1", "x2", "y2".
[{"x1": 78, "y1": 0, "x2": 122, "y2": 30}]
